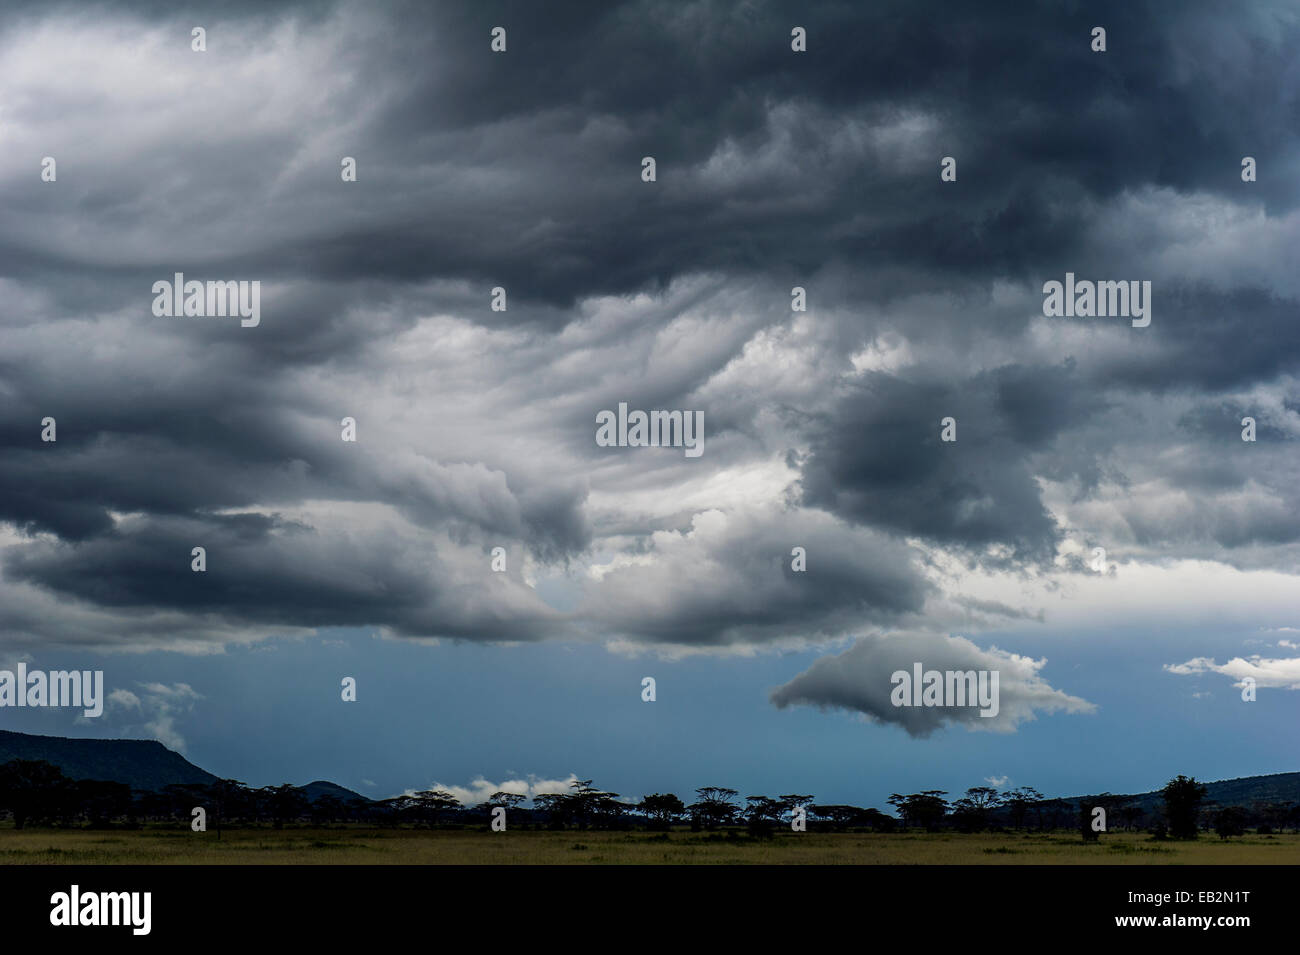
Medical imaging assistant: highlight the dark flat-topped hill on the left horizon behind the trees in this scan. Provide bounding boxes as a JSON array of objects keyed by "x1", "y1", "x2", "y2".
[{"x1": 0, "y1": 730, "x2": 217, "y2": 790}]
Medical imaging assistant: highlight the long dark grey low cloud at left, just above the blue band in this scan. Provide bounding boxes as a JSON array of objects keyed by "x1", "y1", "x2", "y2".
[{"x1": 4, "y1": 513, "x2": 558, "y2": 641}]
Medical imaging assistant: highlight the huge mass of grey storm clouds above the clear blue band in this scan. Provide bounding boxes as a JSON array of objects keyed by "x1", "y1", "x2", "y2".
[{"x1": 0, "y1": 0, "x2": 1300, "y2": 647}]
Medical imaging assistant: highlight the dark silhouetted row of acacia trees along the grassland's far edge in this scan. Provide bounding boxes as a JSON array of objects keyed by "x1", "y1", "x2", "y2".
[{"x1": 0, "y1": 760, "x2": 1300, "y2": 838}]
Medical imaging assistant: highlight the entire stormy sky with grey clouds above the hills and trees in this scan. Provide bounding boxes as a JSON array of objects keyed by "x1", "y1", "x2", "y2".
[{"x1": 0, "y1": 0, "x2": 1300, "y2": 806}]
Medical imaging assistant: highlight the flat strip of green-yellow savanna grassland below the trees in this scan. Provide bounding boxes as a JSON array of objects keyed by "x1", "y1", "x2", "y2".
[{"x1": 0, "y1": 826, "x2": 1300, "y2": 865}]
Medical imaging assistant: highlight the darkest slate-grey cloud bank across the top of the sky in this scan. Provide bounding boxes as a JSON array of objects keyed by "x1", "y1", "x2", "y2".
[{"x1": 7, "y1": 3, "x2": 1297, "y2": 310}]
